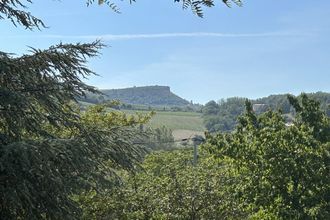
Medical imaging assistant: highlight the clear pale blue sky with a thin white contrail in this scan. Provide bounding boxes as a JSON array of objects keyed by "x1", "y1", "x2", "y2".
[{"x1": 0, "y1": 0, "x2": 330, "y2": 104}]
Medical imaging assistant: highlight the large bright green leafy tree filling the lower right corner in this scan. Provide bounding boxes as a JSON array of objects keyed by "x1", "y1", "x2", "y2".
[{"x1": 206, "y1": 94, "x2": 330, "y2": 219}]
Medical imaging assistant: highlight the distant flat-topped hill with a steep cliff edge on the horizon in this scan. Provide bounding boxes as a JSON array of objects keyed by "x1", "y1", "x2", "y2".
[{"x1": 82, "y1": 86, "x2": 190, "y2": 107}]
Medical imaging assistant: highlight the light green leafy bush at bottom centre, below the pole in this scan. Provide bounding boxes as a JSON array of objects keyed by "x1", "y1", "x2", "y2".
[{"x1": 76, "y1": 150, "x2": 245, "y2": 219}]
